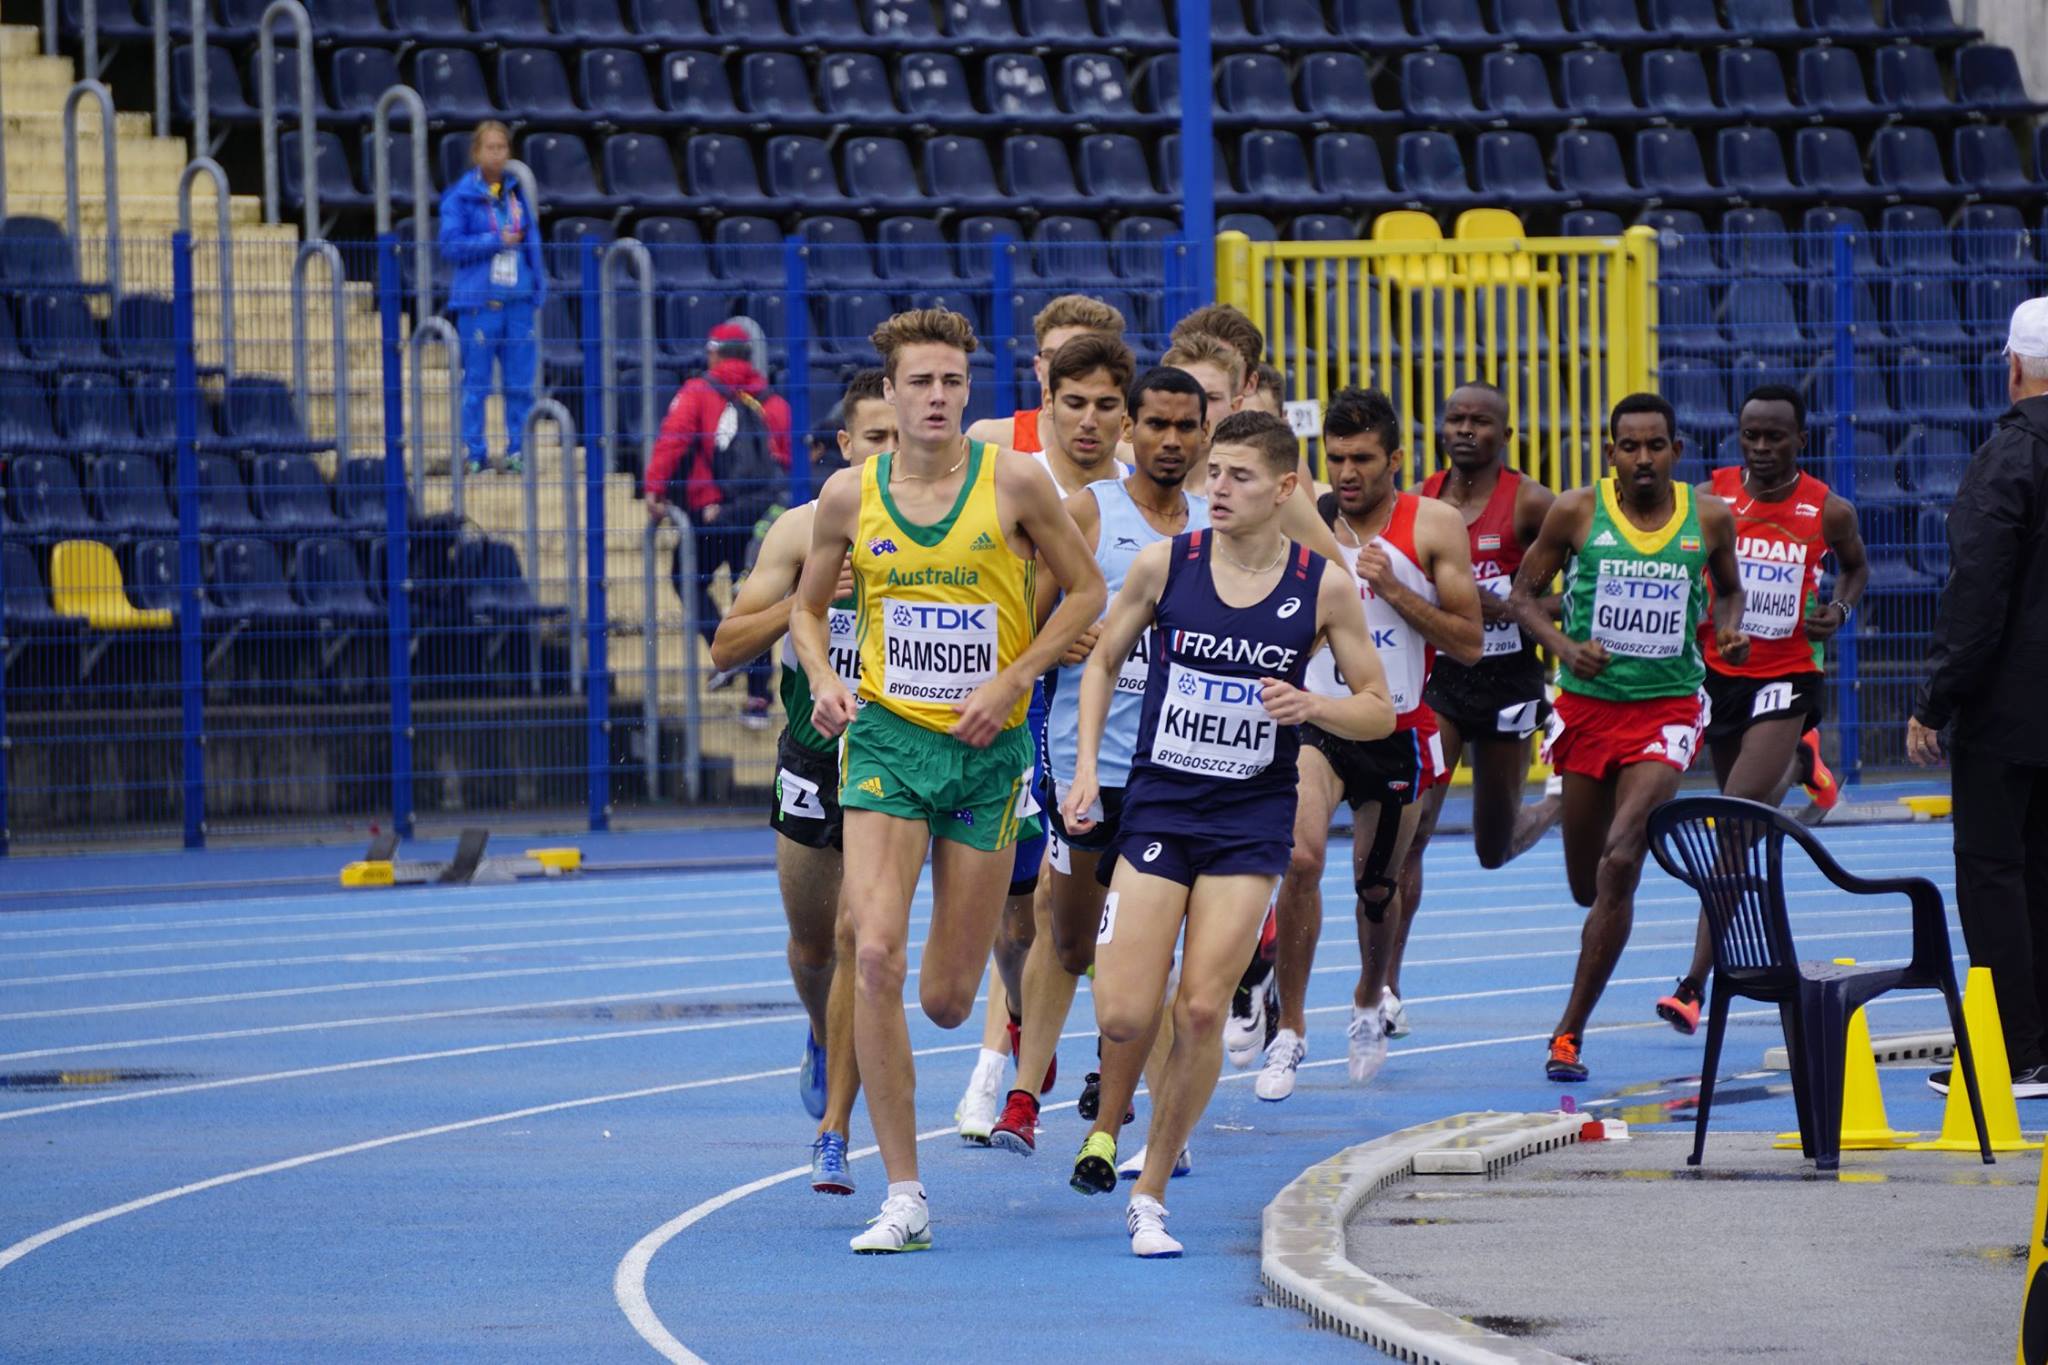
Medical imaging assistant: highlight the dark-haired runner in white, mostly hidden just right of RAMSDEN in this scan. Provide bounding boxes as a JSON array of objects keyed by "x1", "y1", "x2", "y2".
[{"x1": 952, "y1": 333, "x2": 1137, "y2": 1144}]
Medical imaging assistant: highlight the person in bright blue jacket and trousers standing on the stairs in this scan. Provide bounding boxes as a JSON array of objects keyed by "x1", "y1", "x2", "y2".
[{"x1": 440, "y1": 121, "x2": 547, "y2": 475}]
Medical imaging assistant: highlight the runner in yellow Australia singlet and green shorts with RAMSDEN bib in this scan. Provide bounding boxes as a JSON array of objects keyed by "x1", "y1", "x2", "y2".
[{"x1": 791, "y1": 309, "x2": 1106, "y2": 1252}]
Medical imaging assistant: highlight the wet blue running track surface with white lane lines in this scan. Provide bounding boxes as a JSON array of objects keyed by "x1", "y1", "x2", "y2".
[{"x1": 0, "y1": 825, "x2": 1962, "y2": 1361}]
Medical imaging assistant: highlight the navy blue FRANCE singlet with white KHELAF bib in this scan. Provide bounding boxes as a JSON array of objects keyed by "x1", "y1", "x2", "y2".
[{"x1": 1122, "y1": 530, "x2": 1325, "y2": 839}]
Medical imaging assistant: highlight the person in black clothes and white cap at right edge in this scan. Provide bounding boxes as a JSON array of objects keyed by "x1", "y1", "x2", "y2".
[{"x1": 1907, "y1": 299, "x2": 2048, "y2": 1099}]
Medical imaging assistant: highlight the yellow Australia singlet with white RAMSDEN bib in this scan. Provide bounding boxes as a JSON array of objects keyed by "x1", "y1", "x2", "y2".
[{"x1": 854, "y1": 442, "x2": 1038, "y2": 733}]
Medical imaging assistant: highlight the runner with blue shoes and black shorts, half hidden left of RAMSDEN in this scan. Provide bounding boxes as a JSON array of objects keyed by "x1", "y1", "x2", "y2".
[{"x1": 711, "y1": 370, "x2": 897, "y2": 1195}]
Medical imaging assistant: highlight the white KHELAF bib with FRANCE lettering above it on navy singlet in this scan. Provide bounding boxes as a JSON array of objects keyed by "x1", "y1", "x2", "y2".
[{"x1": 1151, "y1": 630, "x2": 1298, "y2": 778}]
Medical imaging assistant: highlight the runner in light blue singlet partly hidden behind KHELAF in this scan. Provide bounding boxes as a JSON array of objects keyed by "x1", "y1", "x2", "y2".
[{"x1": 991, "y1": 362, "x2": 1208, "y2": 1156}]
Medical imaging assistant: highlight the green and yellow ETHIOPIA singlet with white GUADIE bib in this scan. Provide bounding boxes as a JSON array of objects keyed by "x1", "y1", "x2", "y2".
[{"x1": 1556, "y1": 479, "x2": 1706, "y2": 702}]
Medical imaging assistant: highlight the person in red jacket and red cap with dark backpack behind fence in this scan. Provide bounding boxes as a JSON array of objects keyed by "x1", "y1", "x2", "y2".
[{"x1": 645, "y1": 317, "x2": 791, "y2": 731}]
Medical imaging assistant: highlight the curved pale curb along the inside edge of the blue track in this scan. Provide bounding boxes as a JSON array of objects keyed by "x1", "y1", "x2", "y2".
[{"x1": 1260, "y1": 1113, "x2": 1585, "y2": 1365}]
